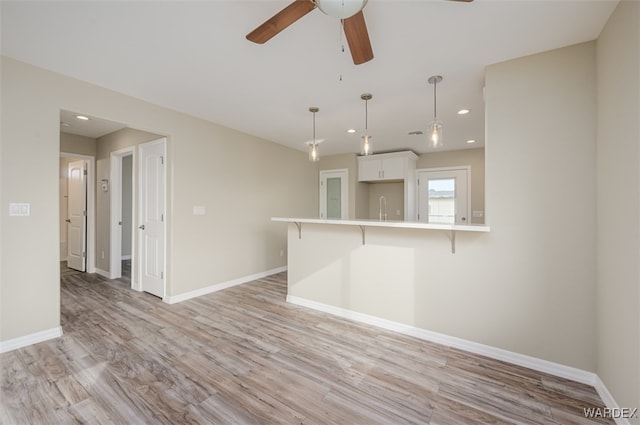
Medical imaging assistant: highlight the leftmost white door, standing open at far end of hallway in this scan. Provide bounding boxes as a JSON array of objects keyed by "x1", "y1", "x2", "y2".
[{"x1": 67, "y1": 160, "x2": 87, "y2": 272}]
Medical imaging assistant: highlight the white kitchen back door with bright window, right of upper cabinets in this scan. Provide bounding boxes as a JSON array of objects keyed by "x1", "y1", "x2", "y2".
[{"x1": 418, "y1": 167, "x2": 470, "y2": 224}]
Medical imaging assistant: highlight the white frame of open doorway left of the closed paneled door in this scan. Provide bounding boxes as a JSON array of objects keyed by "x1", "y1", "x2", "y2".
[{"x1": 109, "y1": 146, "x2": 137, "y2": 289}]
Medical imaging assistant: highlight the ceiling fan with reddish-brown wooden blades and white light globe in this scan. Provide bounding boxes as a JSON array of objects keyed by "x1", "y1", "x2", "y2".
[{"x1": 246, "y1": 0, "x2": 473, "y2": 65}]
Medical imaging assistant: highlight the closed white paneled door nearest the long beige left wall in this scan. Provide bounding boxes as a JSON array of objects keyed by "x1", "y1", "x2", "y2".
[{"x1": 138, "y1": 139, "x2": 165, "y2": 298}]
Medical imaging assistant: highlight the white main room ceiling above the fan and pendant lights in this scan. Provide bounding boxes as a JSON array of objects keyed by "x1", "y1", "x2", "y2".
[{"x1": 1, "y1": 0, "x2": 618, "y2": 155}]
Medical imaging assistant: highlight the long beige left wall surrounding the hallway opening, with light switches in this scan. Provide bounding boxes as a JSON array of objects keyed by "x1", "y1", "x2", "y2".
[{"x1": 0, "y1": 57, "x2": 318, "y2": 341}]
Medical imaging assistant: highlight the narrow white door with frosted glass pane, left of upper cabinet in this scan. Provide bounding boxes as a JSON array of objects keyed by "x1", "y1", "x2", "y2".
[{"x1": 320, "y1": 169, "x2": 349, "y2": 220}]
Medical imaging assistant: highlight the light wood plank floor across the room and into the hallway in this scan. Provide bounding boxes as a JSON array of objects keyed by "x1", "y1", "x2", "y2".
[{"x1": 0, "y1": 269, "x2": 613, "y2": 425}]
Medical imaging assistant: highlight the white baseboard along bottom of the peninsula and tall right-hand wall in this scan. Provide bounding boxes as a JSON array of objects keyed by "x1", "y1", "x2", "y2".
[{"x1": 287, "y1": 295, "x2": 629, "y2": 416}]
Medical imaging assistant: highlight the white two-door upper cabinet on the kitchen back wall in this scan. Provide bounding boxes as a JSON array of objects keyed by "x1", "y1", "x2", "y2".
[{"x1": 358, "y1": 151, "x2": 418, "y2": 182}]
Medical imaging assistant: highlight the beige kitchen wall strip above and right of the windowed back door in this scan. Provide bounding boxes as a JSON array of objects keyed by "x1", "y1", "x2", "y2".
[{"x1": 416, "y1": 148, "x2": 486, "y2": 224}]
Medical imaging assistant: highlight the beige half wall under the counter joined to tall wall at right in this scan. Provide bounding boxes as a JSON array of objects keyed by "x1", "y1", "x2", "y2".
[{"x1": 289, "y1": 43, "x2": 596, "y2": 371}]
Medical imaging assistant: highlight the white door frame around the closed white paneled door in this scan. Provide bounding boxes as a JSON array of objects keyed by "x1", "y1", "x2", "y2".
[{"x1": 138, "y1": 137, "x2": 169, "y2": 296}]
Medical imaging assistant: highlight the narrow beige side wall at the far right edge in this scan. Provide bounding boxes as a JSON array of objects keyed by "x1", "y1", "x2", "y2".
[{"x1": 597, "y1": 1, "x2": 640, "y2": 416}]
